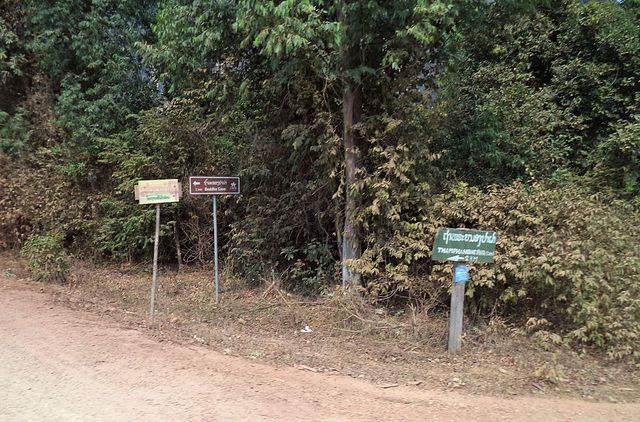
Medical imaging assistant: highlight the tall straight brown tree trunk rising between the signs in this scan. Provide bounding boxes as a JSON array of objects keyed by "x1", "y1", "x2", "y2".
[{"x1": 339, "y1": 0, "x2": 362, "y2": 291}]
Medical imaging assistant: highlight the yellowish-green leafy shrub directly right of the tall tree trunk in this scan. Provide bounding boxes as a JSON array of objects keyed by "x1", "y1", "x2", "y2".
[{"x1": 342, "y1": 112, "x2": 436, "y2": 299}]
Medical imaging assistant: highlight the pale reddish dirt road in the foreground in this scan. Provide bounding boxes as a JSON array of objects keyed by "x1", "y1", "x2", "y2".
[{"x1": 0, "y1": 277, "x2": 640, "y2": 422}]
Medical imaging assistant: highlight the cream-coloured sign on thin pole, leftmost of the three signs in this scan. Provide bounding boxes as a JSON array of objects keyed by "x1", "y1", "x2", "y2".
[{"x1": 135, "y1": 179, "x2": 182, "y2": 324}]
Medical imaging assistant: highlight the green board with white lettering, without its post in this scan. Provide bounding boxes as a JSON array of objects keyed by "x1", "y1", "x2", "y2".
[{"x1": 431, "y1": 229, "x2": 498, "y2": 262}]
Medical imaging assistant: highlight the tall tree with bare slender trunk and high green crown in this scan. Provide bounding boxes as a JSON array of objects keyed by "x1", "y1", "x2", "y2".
[{"x1": 236, "y1": 0, "x2": 452, "y2": 288}]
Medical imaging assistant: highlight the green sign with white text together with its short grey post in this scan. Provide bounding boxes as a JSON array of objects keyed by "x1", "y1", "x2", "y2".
[{"x1": 431, "y1": 229, "x2": 498, "y2": 355}]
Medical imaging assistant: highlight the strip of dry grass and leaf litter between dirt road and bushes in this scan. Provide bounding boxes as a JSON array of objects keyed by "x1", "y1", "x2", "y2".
[{"x1": 0, "y1": 252, "x2": 640, "y2": 401}]
